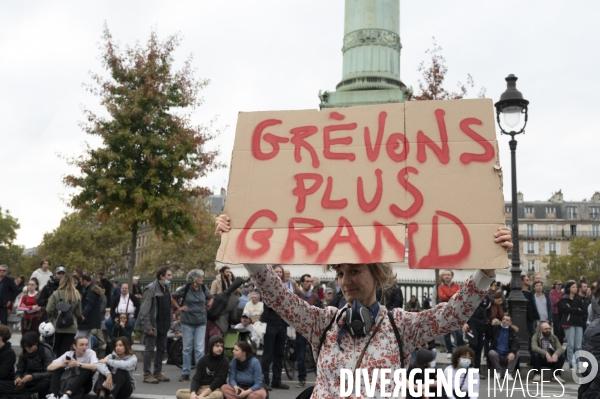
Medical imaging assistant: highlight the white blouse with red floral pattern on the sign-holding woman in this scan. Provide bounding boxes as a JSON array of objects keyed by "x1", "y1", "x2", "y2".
[{"x1": 245, "y1": 265, "x2": 493, "y2": 399}]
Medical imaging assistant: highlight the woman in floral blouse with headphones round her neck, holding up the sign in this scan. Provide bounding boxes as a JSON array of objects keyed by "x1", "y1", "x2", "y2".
[{"x1": 215, "y1": 215, "x2": 513, "y2": 398}]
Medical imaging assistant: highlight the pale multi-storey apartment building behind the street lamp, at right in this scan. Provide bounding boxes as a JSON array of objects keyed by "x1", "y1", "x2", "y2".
[{"x1": 505, "y1": 190, "x2": 600, "y2": 279}]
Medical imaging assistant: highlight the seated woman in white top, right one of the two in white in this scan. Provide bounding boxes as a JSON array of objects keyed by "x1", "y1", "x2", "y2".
[{"x1": 94, "y1": 338, "x2": 138, "y2": 399}]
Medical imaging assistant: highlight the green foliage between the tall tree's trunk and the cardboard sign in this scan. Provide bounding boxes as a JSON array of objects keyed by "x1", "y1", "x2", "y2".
[{"x1": 136, "y1": 201, "x2": 220, "y2": 275}]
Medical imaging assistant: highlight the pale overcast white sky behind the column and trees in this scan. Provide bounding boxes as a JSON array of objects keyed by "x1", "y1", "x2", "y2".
[{"x1": 0, "y1": 0, "x2": 600, "y2": 247}]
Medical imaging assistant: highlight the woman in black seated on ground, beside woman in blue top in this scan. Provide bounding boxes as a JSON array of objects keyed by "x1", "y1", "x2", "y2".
[{"x1": 175, "y1": 337, "x2": 229, "y2": 399}]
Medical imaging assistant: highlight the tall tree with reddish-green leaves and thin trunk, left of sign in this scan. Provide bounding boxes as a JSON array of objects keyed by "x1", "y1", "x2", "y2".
[{"x1": 64, "y1": 26, "x2": 222, "y2": 288}]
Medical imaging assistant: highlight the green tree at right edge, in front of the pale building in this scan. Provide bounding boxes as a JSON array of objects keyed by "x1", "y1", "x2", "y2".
[{"x1": 545, "y1": 238, "x2": 600, "y2": 282}]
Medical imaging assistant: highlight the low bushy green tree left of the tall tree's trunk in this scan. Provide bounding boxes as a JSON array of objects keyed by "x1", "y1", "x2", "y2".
[{"x1": 36, "y1": 212, "x2": 129, "y2": 273}]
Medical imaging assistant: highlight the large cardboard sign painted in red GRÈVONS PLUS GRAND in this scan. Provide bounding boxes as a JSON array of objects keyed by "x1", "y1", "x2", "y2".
[{"x1": 217, "y1": 99, "x2": 508, "y2": 269}]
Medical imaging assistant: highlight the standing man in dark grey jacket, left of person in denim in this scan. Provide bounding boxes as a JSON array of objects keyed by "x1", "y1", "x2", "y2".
[{"x1": 134, "y1": 266, "x2": 173, "y2": 384}]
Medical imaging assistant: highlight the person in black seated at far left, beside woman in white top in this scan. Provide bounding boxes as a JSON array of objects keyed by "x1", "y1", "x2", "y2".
[{"x1": 0, "y1": 332, "x2": 54, "y2": 399}]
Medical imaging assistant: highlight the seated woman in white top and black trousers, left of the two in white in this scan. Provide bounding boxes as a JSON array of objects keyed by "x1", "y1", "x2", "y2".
[{"x1": 47, "y1": 338, "x2": 98, "y2": 399}]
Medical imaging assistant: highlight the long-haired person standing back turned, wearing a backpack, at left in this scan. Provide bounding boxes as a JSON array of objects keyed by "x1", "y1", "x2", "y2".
[{"x1": 46, "y1": 274, "x2": 81, "y2": 354}]
